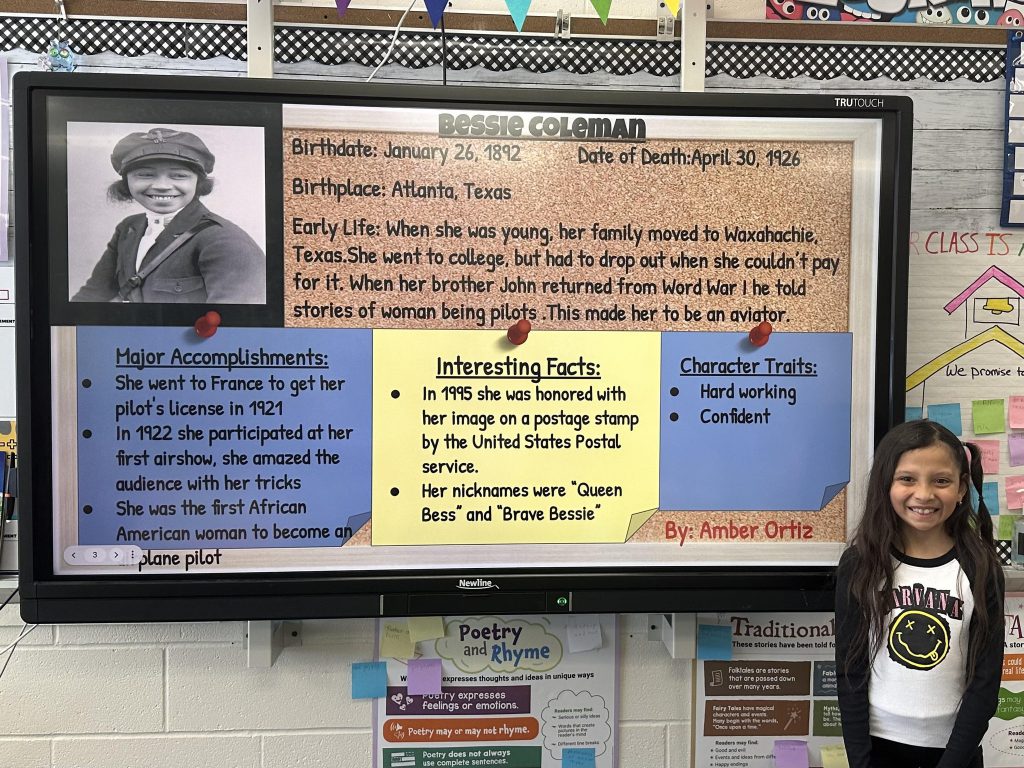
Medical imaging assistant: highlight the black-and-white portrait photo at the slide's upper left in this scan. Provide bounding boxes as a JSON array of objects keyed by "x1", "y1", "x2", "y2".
[{"x1": 68, "y1": 122, "x2": 267, "y2": 304}]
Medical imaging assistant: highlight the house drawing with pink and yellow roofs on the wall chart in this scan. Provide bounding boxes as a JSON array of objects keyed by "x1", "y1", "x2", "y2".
[{"x1": 906, "y1": 265, "x2": 1024, "y2": 392}]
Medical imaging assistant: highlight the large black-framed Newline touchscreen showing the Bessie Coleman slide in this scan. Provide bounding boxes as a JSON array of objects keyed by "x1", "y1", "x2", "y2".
[{"x1": 15, "y1": 73, "x2": 910, "y2": 621}]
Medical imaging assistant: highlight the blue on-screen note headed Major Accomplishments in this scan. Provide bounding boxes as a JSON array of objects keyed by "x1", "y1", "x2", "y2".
[{"x1": 77, "y1": 327, "x2": 372, "y2": 549}]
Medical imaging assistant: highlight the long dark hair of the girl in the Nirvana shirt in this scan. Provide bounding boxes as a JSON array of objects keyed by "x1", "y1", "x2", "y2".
[{"x1": 847, "y1": 420, "x2": 1001, "y2": 681}]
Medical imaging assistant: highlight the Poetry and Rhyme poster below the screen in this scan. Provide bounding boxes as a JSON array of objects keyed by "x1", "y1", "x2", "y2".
[{"x1": 374, "y1": 614, "x2": 620, "y2": 768}]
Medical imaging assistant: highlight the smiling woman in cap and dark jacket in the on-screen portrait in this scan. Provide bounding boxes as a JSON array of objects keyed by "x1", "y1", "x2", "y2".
[{"x1": 72, "y1": 128, "x2": 266, "y2": 304}]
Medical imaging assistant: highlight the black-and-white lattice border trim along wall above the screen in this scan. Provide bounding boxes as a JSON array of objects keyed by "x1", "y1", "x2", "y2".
[{"x1": 0, "y1": 15, "x2": 1005, "y2": 82}]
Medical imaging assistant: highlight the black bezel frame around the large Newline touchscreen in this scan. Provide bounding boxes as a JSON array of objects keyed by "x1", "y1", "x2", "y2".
[{"x1": 13, "y1": 73, "x2": 912, "y2": 623}]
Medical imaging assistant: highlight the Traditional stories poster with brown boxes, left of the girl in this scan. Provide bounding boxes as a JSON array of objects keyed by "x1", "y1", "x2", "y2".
[{"x1": 694, "y1": 612, "x2": 843, "y2": 768}]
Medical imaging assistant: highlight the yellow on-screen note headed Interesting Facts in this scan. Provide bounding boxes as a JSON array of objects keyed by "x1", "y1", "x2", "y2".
[{"x1": 373, "y1": 331, "x2": 660, "y2": 546}]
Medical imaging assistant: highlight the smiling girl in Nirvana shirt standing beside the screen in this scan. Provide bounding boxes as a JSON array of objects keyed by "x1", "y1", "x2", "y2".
[{"x1": 836, "y1": 421, "x2": 1004, "y2": 768}]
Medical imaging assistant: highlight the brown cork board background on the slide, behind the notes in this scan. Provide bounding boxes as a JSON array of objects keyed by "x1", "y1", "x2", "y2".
[{"x1": 284, "y1": 129, "x2": 853, "y2": 546}]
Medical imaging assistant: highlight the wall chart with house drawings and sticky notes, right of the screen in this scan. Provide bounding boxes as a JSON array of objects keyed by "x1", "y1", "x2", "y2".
[{"x1": 905, "y1": 229, "x2": 1024, "y2": 562}]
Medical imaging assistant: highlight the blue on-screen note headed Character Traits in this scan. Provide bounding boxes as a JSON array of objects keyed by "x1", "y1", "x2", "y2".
[{"x1": 660, "y1": 333, "x2": 853, "y2": 511}]
